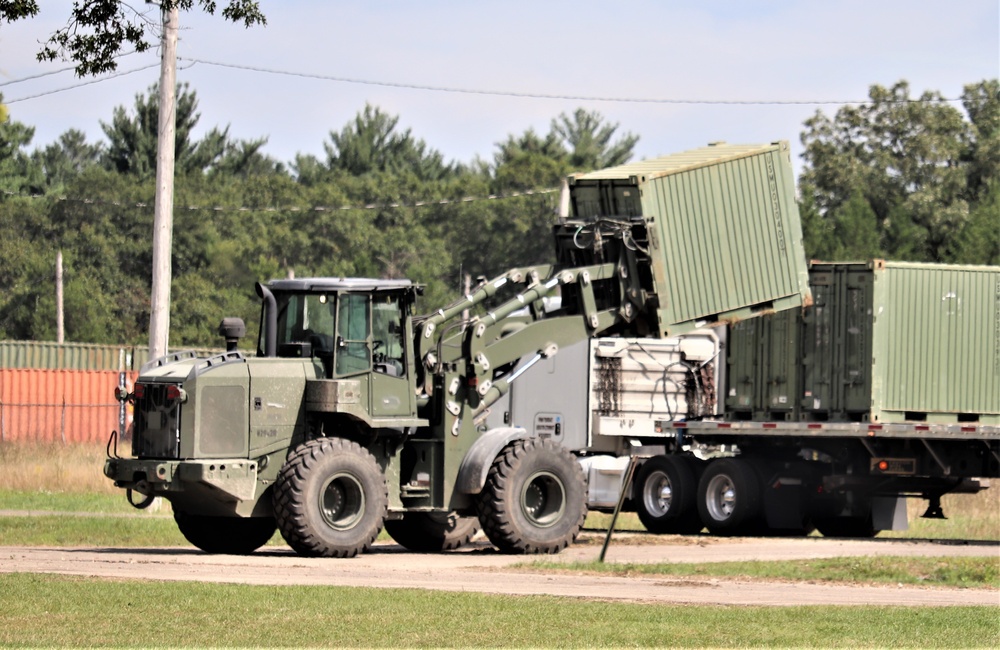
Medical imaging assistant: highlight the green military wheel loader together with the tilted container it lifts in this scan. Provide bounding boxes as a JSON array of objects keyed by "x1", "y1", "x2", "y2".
[{"x1": 104, "y1": 142, "x2": 811, "y2": 557}]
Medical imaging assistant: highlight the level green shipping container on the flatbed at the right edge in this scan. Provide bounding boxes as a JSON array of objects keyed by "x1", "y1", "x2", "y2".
[{"x1": 803, "y1": 260, "x2": 1000, "y2": 424}]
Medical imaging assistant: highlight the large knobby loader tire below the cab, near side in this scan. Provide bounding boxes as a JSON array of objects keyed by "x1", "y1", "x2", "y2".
[{"x1": 273, "y1": 438, "x2": 389, "y2": 557}]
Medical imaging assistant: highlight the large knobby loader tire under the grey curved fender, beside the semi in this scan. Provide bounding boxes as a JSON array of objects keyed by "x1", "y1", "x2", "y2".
[{"x1": 476, "y1": 438, "x2": 587, "y2": 554}]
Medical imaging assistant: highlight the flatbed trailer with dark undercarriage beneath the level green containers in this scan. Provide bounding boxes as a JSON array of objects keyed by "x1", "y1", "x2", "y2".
[{"x1": 635, "y1": 420, "x2": 1000, "y2": 537}]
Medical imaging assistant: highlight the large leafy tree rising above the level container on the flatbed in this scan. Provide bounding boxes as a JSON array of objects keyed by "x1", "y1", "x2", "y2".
[{"x1": 800, "y1": 81, "x2": 998, "y2": 262}]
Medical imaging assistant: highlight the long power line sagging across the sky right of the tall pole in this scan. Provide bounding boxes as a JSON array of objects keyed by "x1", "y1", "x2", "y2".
[{"x1": 177, "y1": 57, "x2": 961, "y2": 106}]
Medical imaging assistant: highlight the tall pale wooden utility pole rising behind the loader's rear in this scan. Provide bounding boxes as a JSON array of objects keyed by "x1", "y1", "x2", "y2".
[{"x1": 149, "y1": 5, "x2": 180, "y2": 359}]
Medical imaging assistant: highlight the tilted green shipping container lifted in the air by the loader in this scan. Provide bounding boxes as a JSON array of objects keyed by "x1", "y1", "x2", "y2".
[{"x1": 569, "y1": 142, "x2": 810, "y2": 336}]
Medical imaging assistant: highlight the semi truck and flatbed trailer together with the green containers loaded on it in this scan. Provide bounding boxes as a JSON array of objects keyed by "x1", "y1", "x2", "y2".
[{"x1": 492, "y1": 260, "x2": 1000, "y2": 537}]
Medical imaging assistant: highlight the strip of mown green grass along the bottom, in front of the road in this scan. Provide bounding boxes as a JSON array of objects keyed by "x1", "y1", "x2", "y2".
[{"x1": 0, "y1": 574, "x2": 1000, "y2": 648}]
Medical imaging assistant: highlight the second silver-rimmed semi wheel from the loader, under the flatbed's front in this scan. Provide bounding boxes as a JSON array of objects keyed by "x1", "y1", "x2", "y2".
[{"x1": 698, "y1": 458, "x2": 760, "y2": 535}]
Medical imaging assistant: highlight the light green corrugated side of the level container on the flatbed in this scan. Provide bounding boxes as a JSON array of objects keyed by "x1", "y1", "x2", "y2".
[{"x1": 871, "y1": 262, "x2": 1000, "y2": 424}]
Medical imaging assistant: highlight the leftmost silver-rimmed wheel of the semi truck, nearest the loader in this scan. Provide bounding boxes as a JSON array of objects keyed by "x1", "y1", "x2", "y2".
[{"x1": 633, "y1": 456, "x2": 703, "y2": 535}]
